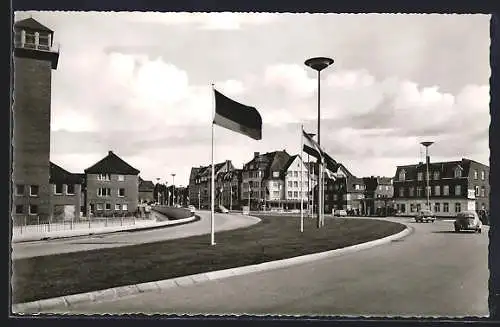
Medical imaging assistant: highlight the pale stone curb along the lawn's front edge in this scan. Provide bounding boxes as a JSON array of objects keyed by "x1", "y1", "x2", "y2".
[{"x1": 12, "y1": 224, "x2": 413, "y2": 314}]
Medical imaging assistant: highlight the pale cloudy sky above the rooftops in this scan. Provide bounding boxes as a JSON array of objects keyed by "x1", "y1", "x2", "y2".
[{"x1": 15, "y1": 12, "x2": 490, "y2": 185}]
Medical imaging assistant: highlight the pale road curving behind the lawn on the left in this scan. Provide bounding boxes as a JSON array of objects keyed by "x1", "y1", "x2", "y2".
[{"x1": 12, "y1": 211, "x2": 259, "y2": 260}]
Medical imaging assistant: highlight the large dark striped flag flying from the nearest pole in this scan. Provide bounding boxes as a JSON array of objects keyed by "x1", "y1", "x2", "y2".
[{"x1": 213, "y1": 89, "x2": 262, "y2": 140}]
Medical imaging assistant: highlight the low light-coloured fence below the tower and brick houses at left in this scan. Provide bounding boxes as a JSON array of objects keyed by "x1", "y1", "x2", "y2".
[{"x1": 12, "y1": 214, "x2": 151, "y2": 236}]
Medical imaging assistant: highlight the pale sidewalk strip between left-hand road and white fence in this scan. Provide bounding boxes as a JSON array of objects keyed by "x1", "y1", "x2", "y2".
[{"x1": 12, "y1": 216, "x2": 196, "y2": 243}]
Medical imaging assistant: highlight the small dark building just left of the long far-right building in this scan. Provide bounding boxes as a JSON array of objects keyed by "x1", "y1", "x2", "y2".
[{"x1": 362, "y1": 176, "x2": 394, "y2": 216}]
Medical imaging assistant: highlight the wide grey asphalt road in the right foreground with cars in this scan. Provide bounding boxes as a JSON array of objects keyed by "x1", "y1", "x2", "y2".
[{"x1": 50, "y1": 218, "x2": 489, "y2": 317}]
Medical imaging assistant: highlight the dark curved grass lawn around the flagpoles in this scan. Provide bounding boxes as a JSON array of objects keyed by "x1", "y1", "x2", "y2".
[{"x1": 12, "y1": 216, "x2": 405, "y2": 303}]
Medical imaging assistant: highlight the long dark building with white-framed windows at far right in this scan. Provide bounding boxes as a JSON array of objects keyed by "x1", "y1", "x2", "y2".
[{"x1": 393, "y1": 157, "x2": 490, "y2": 216}]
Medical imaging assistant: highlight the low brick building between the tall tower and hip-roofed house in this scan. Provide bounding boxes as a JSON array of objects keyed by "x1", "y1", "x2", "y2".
[{"x1": 49, "y1": 162, "x2": 85, "y2": 222}]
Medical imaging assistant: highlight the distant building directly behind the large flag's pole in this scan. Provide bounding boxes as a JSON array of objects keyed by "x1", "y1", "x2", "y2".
[{"x1": 189, "y1": 160, "x2": 234, "y2": 209}]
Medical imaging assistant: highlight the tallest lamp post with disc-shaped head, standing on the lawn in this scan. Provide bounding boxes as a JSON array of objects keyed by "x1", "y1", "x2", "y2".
[{"x1": 304, "y1": 57, "x2": 333, "y2": 228}]
